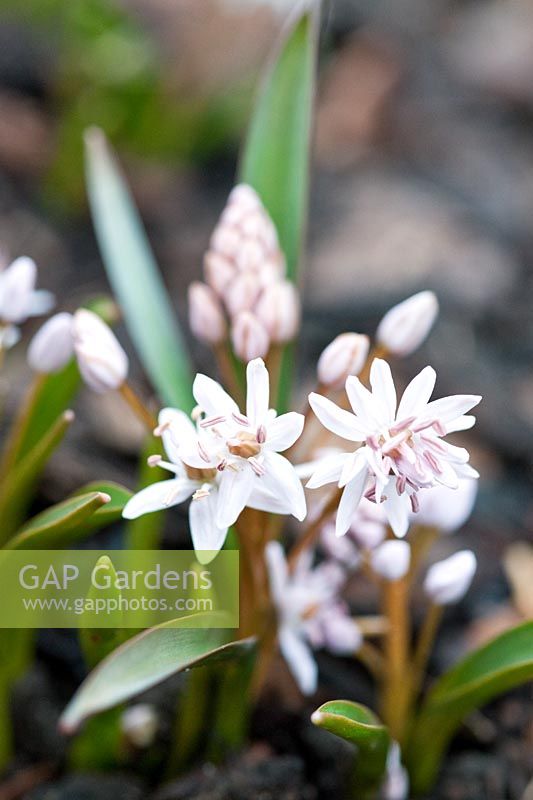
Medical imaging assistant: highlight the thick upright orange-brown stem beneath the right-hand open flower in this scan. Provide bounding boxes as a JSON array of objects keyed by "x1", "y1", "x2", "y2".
[{"x1": 381, "y1": 578, "x2": 410, "y2": 743}]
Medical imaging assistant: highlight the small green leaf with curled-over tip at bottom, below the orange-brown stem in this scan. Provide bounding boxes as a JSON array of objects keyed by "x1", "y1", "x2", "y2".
[{"x1": 311, "y1": 700, "x2": 391, "y2": 798}]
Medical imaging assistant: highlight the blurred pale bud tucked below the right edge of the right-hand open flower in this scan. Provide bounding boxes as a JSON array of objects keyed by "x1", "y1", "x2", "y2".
[{"x1": 412, "y1": 478, "x2": 478, "y2": 533}]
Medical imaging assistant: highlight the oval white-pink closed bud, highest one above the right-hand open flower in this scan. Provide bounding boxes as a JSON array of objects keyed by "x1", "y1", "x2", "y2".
[{"x1": 376, "y1": 291, "x2": 439, "y2": 356}]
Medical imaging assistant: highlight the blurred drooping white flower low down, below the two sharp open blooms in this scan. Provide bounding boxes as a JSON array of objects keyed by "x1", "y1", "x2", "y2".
[{"x1": 266, "y1": 542, "x2": 363, "y2": 694}]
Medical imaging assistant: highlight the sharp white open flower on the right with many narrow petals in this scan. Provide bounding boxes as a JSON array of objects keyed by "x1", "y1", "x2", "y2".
[{"x1": 307, "y1": 358, "x2": 481, "y2": 537}]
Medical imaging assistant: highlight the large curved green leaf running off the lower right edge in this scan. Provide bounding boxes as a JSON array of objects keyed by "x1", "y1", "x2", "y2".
[{"x1": 407, "y1": 622, "x2": 533, "y2": 792}]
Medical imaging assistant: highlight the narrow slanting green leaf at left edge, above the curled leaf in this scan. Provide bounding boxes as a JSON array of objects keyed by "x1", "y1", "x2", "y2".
[{"x1": 0, "y1": 411, "x2": 74, "y2": 541}]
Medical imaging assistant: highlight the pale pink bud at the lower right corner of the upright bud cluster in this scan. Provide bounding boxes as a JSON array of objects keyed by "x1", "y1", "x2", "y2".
[{"x1": 255, "y1": 281, "x2": 300, "y2": 344}]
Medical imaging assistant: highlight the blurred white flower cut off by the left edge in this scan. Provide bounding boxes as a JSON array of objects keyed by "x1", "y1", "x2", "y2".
[{"x1": 0, "y1": 256, "x2": 54, "y2": 349}]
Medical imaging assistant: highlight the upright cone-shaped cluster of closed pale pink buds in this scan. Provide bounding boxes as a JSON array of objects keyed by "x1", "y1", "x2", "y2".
[{"x1": 189, "y1": 184, "x2": 300, "y2": 362}]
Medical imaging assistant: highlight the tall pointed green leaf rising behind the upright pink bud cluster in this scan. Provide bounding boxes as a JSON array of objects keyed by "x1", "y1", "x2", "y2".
[{"x1": 240, "y1": 0, "x2": 320, "y2": 411}]
